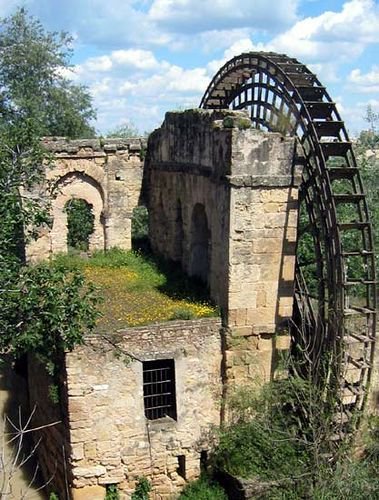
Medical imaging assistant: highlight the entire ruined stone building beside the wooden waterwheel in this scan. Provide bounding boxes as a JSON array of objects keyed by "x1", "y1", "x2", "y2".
[{"x1": 28, "y1": 110, "x2": 306, "y2": 500}]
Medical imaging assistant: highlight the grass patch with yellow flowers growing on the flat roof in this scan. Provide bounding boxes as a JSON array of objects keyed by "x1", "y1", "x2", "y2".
[{"x1": 55, "y1": 248, "x2": 217, "y2": 332}]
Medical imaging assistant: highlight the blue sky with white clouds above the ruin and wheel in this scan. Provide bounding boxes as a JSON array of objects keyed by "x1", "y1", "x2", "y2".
[{"x1": 0, "y1": 0, "x2": 379, "y2": 135}]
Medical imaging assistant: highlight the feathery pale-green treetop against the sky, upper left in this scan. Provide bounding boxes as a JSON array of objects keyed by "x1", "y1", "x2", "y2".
[{"x1": 0, "y1": 8, "x2": 95, "y2": 138}]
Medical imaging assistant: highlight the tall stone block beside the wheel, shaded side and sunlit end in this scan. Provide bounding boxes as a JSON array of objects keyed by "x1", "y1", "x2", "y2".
[{"x1": 145, "y1": 110, "x2": 301, "y2": 383}]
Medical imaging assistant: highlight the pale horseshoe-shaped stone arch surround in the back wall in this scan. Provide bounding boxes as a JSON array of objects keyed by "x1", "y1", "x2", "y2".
[{"x1": 50, "y1": 172, "x2": 106, "y2": 253}]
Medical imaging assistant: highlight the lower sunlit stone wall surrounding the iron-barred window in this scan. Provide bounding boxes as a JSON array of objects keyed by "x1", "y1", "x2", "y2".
[{"x1": 66, "y1": 318, "x2": 222, "y2": 500}]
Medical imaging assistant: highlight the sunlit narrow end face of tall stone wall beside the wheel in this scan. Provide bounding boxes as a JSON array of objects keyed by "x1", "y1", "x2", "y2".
[{"x1": 226, "y1": 130, "x2": 300, "y2": 384}]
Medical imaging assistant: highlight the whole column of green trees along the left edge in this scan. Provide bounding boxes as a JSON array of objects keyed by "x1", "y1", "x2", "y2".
[{"x1": 0, "y1": 10, "x2": 97, "y2": 376}]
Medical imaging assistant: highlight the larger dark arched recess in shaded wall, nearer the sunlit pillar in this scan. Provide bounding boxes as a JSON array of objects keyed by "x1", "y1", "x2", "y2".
[{"x1": 189, "y1": 203, "x2": 211, "y2": 284}]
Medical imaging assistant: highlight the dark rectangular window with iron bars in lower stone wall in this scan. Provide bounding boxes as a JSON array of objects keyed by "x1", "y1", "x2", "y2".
[{"x1": 143, "y1": 359, "x2": 176, "y2": 420}]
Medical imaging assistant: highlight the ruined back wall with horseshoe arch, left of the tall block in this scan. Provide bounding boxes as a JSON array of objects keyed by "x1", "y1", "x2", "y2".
[{"x1": 27, "y1": 139, "x2": 145, "y2": 260}]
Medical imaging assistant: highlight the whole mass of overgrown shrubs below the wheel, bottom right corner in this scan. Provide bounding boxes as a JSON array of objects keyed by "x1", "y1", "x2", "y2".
[{"x1": 205, "y1": 364, "x2": 379, "y2": 500}]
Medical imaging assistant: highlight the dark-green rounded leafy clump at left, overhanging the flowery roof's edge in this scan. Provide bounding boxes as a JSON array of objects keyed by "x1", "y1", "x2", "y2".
[{"x1": 0, "y1": 263, "x2": 98, "y2": 374}]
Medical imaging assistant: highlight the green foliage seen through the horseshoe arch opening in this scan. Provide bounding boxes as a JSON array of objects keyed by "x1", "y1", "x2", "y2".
[{"x1": 65, "y1": 198, "x2": 95, "y2": 251}]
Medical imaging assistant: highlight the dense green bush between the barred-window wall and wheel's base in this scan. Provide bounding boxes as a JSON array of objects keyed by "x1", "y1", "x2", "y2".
[{"x1": 212, "y1": 379, "x2": 310, "y2": 480}]
